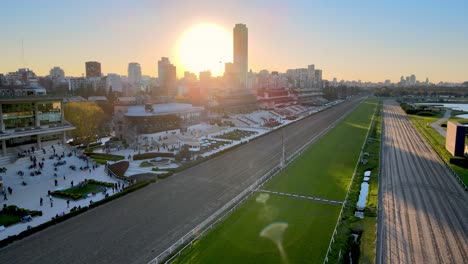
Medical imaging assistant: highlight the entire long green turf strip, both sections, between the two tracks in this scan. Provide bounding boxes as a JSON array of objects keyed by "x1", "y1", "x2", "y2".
[{"x1": 174, "y1": 101, "x2": 377, "y2": 263}]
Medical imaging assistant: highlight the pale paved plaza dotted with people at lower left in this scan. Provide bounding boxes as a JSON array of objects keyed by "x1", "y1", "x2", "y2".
[{"x1": 0, "y1": 144, "x2": 118, "y2": 240}]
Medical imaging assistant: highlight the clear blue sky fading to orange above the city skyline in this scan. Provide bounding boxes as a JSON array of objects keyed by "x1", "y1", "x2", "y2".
[{"x1": 0, "y1": 0, "x2": 468, "y2": 82}]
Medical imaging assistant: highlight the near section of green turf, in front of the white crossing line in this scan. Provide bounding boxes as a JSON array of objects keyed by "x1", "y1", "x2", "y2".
[{"x1": 174, "y1": 193, "x2": 341, "y2": 263}]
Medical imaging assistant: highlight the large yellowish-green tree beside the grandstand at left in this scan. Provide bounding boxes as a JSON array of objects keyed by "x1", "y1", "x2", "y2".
[{"x1": 65, "y1": 102, "x2": 105, "y2": 144}]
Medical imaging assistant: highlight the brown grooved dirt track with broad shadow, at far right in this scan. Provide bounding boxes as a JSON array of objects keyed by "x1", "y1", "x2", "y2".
[{"x1": 377, "y1": 101, "x2": 468, "y2": 263}]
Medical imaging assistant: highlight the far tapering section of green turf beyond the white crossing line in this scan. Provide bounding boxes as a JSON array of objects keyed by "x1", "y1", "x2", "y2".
[{"x1": 265, "y1": 101, "x2": 377, "y2": 201}]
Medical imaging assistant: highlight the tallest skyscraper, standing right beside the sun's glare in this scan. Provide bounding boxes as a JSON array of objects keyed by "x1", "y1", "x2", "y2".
[{"x1": 234, "y1": 24, "x2": 249, "y2": 88}]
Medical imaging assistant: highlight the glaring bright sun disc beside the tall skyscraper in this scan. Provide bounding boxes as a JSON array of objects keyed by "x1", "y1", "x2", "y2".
[{"x1": 177, "y1": 23, "x2": 232, "y2": 75}]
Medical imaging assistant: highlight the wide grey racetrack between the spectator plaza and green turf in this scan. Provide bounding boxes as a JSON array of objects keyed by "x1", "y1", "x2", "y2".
[{"x1": 0, "y1": 98, "x2": 361, "y2": 264}]
